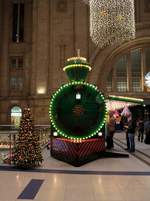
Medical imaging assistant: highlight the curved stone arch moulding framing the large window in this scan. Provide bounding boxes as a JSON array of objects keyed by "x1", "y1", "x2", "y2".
[{"x1": 89, "y1": 37, "x2": 150, "y2": 92}]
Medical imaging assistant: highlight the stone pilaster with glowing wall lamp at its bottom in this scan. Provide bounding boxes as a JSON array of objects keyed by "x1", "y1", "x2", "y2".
[{"x1": 31, "y1": 0, "x2": 49, "y2": 95}]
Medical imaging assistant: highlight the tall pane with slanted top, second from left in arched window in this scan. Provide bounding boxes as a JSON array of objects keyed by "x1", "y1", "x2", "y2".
[{"x1": 115, "y1": 56, "x2": 127, "y2": 92}]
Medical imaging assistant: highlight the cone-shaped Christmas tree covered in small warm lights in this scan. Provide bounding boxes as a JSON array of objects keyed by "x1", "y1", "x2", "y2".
[{"x1": 13, "y1": 108, "x2": 43, "y2": 168}]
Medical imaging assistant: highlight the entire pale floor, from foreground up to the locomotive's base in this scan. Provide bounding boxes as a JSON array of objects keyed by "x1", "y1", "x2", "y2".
[{"x1": 0, "y1": 131, "x2": 150, "y2": 201}]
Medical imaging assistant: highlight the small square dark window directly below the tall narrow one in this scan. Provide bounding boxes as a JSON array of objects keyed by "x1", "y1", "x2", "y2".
[{"x1": 10, "y1": 56, "x2": 23, "y2": 69}]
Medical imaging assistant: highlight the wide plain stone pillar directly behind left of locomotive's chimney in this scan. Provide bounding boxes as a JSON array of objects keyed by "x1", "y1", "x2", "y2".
[{"x1": 49, "y1": 0, "x2": 75, "y2": 89}]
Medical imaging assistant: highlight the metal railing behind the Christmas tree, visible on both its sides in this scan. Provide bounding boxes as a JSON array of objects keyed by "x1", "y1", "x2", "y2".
[{"x1": 0, "y1": 125, "x2": 50, "y2": 164}]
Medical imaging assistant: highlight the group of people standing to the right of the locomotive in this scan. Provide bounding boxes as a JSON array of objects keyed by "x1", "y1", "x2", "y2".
[{"x1": 106, "y1": 112, "x2": 150, "y2": 152}]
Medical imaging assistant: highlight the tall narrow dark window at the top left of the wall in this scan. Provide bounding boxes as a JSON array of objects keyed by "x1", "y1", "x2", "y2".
[{"x1": 12, "y1": 0, "x2": 24, "y2": 43}]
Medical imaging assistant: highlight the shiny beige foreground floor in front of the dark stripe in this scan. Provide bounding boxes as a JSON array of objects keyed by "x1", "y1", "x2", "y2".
[{"x1": 0, "y1": 172, "x2": 150, "y2": 201}]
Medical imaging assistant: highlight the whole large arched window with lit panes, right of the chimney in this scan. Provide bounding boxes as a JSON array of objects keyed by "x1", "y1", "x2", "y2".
[{"x1": 106, "y1": 47, "x2": 150, "y2": 92}]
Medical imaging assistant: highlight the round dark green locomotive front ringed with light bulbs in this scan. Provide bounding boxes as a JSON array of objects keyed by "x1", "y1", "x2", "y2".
[{"x1": 49, "y1": 82, "x2": 106, "y2": 139}]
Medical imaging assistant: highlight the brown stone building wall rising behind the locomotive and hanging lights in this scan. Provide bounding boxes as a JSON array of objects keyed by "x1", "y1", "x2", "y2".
[{"x1": 0, "y1": 0, "x2": 150, "y2": 124}]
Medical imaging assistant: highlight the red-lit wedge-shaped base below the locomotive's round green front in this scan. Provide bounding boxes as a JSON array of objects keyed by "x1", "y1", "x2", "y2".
[{"x1": 51, "y1": 136, "x2": 105, "y2": 166}]
